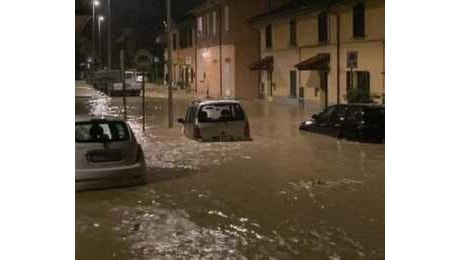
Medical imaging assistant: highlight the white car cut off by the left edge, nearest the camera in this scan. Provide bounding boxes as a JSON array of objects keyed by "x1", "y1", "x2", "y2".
[{"x1": 75, "y1": 116, "x2": 146, "y2": 191}]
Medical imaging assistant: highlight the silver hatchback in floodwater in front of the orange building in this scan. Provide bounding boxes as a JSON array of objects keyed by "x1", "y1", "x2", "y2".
[{"x1": 177, "y1": 100, "x2": 251, "y2": 142}]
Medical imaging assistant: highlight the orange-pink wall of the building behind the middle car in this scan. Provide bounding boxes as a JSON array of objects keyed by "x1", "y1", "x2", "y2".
[{"x1": 195, "y1": 0, "x2": 267, "y2": 99}]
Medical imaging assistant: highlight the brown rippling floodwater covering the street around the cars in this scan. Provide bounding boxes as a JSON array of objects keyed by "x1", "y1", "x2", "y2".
[{"x1": 75, "y1": 86, "x2": 385, "y2": 260}]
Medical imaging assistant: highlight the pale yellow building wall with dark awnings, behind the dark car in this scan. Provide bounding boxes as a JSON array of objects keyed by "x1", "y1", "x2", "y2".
[{"x1": 257, "y1": 0, "x2": 385, "y2": 104}]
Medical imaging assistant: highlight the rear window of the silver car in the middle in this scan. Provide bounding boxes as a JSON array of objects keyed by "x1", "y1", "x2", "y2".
[{"x1": 198, "y1": 103, "x2": 244, "y2": 123}]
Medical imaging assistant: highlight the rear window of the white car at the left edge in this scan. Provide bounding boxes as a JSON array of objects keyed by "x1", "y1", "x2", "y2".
[{"x1": 75, "y1": 121, "x2": 129, "y2": 143}]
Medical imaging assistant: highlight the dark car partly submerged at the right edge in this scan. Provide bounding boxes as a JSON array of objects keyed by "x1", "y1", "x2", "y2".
[{"x1": 299, "y1": 104, "x2": 385, "y2": 142}]
